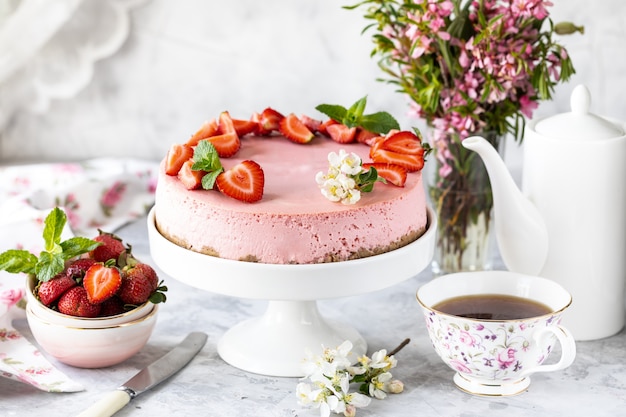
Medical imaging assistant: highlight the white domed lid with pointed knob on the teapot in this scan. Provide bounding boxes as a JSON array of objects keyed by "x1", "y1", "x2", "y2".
[{"x1": 535, "y1": 84, "x2": 624, "y2": 140}]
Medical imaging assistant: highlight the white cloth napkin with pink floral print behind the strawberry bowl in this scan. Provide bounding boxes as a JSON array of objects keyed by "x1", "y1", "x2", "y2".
[{"x1": 0, "y1": 158, "x2": 158, "y2": 392}]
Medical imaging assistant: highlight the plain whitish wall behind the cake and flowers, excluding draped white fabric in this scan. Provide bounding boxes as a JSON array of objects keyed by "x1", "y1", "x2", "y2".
[{"x1": 0, "y1": 0, "x2": 626, "y2": 163}]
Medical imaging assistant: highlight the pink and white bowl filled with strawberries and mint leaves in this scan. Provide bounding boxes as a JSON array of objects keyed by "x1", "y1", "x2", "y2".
[{"x1": 0, "y1": 208, "x2": 167, "y2": 368}]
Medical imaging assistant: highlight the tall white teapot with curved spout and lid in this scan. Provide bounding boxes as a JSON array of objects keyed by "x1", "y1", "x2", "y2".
[{"x1": 463, "y1": 85, "x2": 626, "y2": 340}]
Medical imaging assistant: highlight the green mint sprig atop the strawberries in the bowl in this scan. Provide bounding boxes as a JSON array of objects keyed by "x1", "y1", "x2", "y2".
[{"x1": 0, "y1": 207, "x2": 101, "y2": 282}]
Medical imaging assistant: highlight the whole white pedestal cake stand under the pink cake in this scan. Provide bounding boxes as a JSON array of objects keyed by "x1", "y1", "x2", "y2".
[{"x1": 148, "y1": 208, "x2": 437, "y2": 377}]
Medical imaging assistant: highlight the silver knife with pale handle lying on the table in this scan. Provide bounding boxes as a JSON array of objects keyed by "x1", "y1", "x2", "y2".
[{"x1": 78, "y1": 332, "x2": 208, "y2": 417}]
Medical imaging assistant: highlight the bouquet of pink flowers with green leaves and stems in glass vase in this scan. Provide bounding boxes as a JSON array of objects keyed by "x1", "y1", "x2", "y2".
[{"x1": 347, "y1": 0, "x2": 583, "y2": 272}]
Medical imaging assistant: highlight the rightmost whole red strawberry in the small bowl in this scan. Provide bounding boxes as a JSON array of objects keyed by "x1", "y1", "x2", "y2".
[{"x1": 117, "y1": 263, "x2": 167, "y2": 305}]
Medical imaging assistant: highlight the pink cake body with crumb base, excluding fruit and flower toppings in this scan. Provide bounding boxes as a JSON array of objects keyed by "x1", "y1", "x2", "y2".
[{"x1": 155, "y1": 136, "x2": 427, "y2": 264}]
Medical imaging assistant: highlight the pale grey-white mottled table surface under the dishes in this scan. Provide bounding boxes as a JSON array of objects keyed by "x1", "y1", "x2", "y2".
[{"x1": 0, "y1": 216, "x2": 626, "y2": 417}]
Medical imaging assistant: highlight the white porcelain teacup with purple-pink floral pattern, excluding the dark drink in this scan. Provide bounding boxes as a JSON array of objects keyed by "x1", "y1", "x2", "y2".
[{"x1": 417, "y1": 271, "x2": 576, "y2": 396}]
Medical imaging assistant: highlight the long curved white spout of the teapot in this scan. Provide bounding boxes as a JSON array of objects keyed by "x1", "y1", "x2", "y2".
[{"x1": 463, "y1": 136, "x2": 548, "y2": 275}]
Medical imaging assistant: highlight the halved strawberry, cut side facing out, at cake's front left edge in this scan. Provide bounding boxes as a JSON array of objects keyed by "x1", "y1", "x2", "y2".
[{"x1": 215, "y1": 160, "x2": 265, "y2": 203}]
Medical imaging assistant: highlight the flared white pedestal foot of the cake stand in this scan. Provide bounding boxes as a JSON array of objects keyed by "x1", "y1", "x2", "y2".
[{"x1": 217, "y1": 301, "x2": 367, "y2": 377}]
